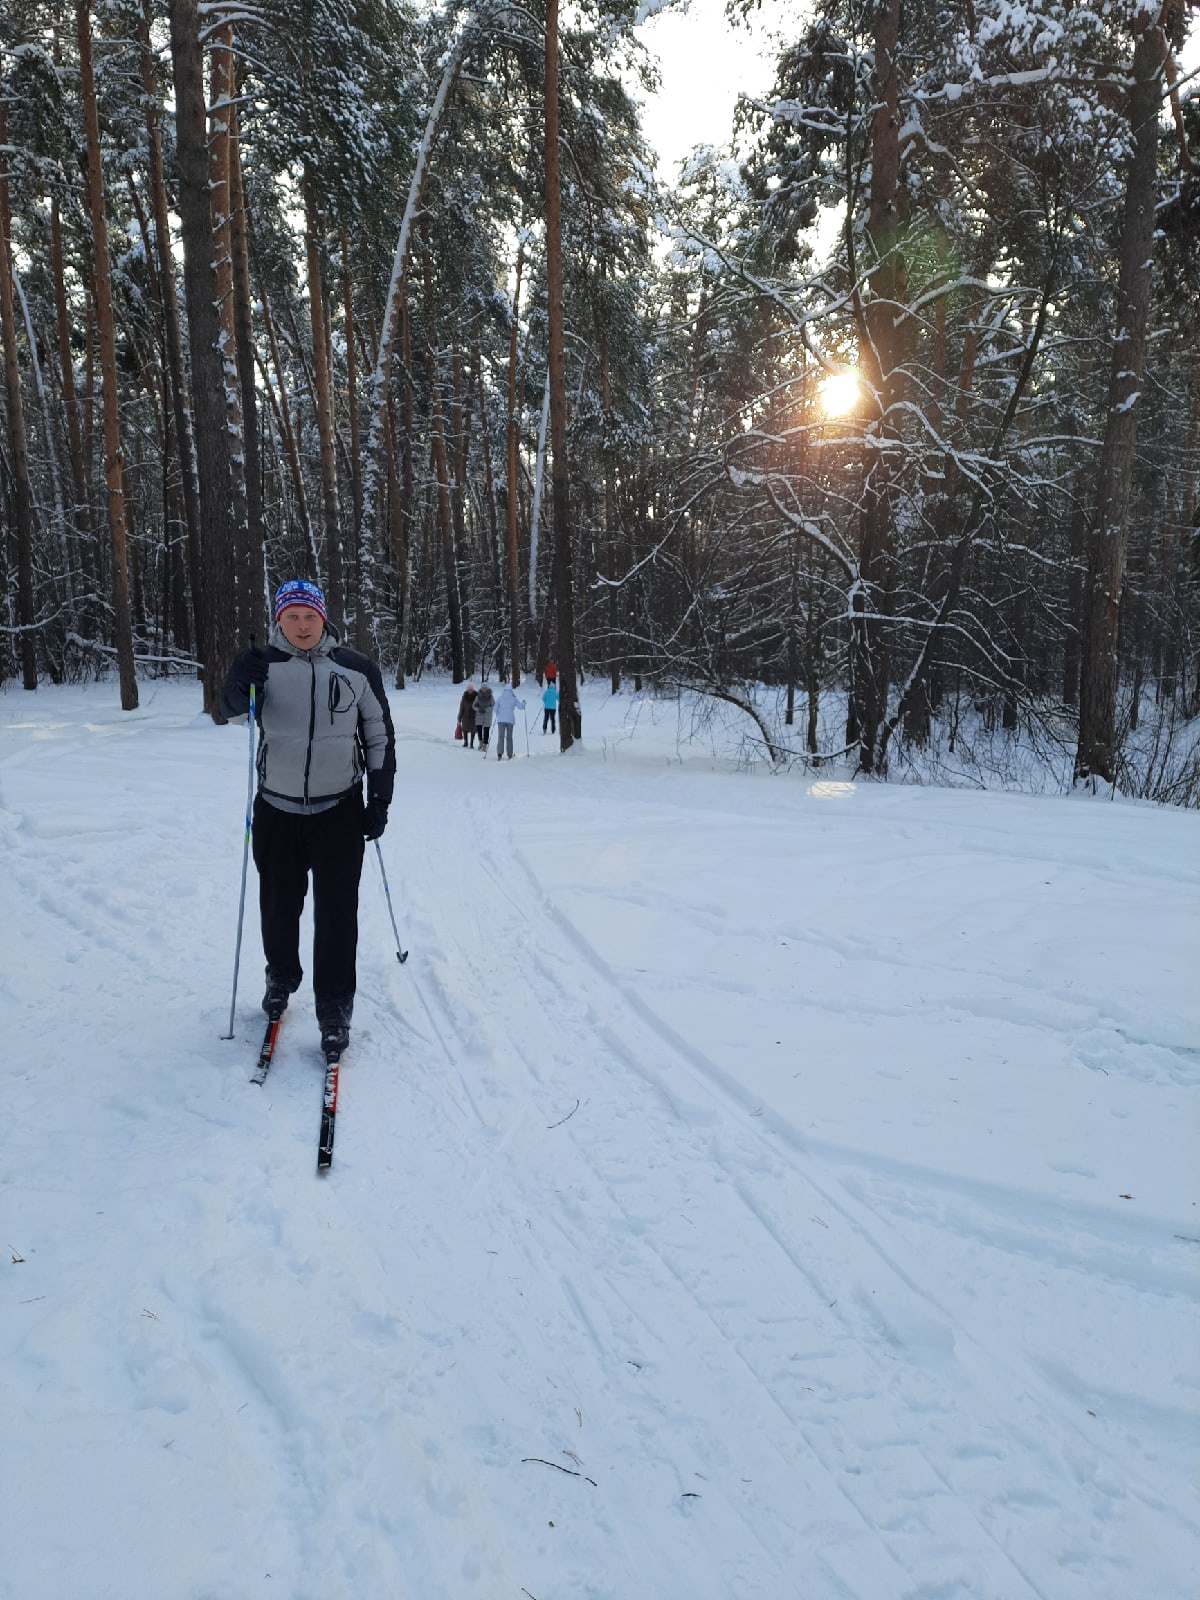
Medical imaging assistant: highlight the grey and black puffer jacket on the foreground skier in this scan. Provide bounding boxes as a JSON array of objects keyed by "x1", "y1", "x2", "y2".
[{"x1": 221, "y1": 622, "x2": 395, "y2": 811}]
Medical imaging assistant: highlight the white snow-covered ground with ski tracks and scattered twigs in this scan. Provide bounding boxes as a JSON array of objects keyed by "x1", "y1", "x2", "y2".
[{"x1": 0, "y1": 682, "x2": 1200, "y2": 1600}]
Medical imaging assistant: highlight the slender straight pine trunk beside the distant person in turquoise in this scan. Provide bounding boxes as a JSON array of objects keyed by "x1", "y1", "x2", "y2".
[{"x1": 546, "y1": 0, "x2": 582, "y2": 750}]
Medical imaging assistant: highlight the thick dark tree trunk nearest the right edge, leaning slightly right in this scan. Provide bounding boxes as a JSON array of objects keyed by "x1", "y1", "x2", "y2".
[{"x1": 1075, "y1": 13, "x2": 1166, "y2": 782}]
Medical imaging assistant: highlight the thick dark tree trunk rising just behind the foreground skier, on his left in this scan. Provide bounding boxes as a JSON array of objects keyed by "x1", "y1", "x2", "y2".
[{"x1": 170, "y1": 0, "x2": 237, "y2": 722}]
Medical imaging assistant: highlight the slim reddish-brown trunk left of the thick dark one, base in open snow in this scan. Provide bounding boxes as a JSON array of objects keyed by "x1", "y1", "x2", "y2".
[{"x1": 75, "y1": 0, "x2": 138, "y2": 710}]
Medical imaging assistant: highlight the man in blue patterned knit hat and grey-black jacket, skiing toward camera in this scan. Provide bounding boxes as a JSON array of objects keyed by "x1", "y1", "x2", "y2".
[{"x1": 221, "y1": 578, "x2": 395, "y2": 1061}]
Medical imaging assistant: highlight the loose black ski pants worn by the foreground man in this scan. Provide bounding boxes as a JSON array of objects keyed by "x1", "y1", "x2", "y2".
[{"x1": 251, "y1": 790, "x2": 365, "y2": 1027}]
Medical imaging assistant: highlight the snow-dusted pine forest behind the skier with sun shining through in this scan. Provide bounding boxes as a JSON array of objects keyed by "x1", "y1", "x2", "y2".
[{"x1": 0, "y1": 0, "x2": 1200, "y2": 803}]
